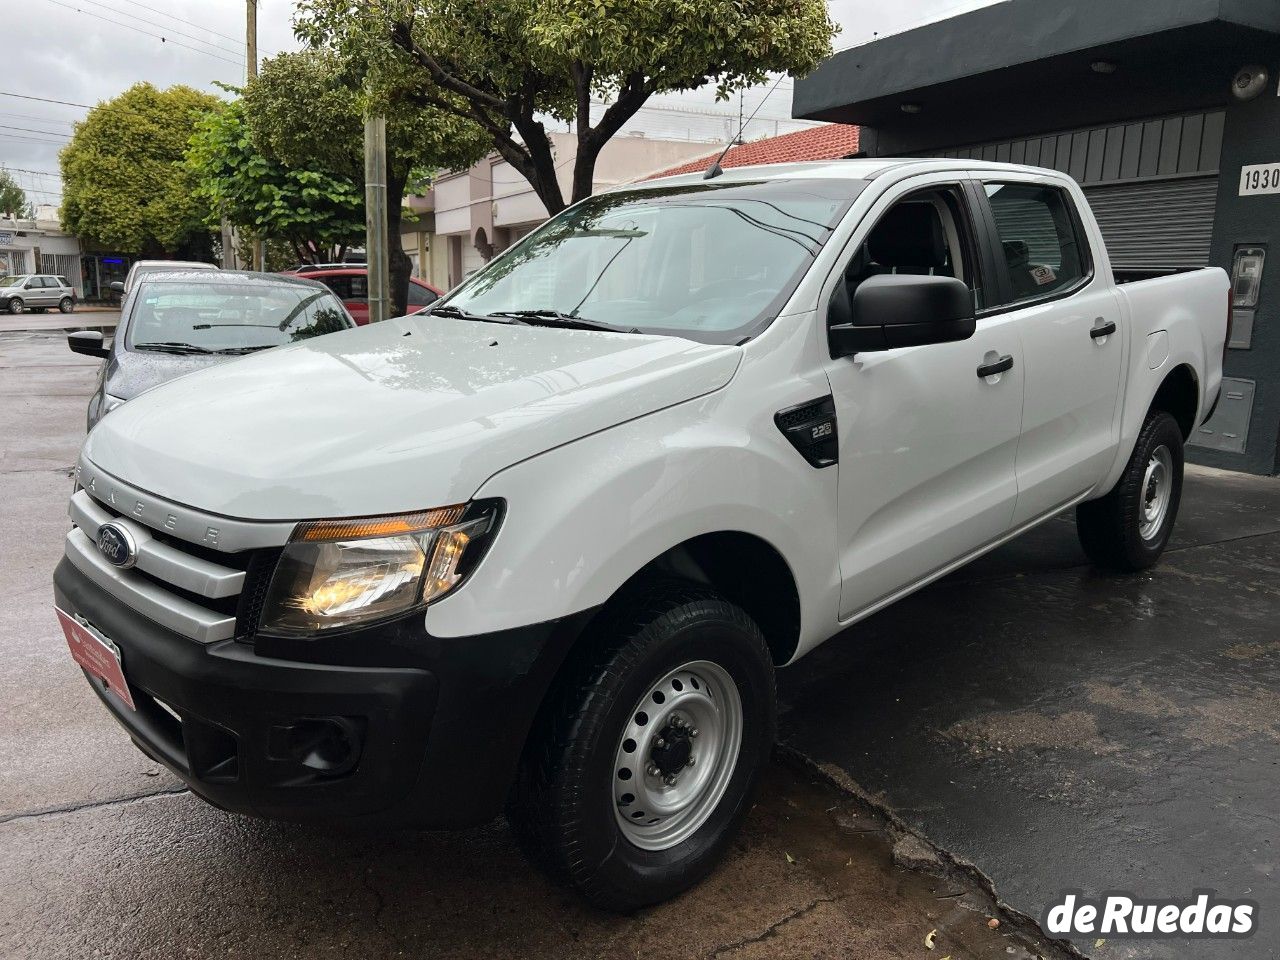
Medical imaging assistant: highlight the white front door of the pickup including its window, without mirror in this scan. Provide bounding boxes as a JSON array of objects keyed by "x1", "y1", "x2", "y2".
[{"x1": 828, "y1": 178, "x2": 1023, "y2": 620}]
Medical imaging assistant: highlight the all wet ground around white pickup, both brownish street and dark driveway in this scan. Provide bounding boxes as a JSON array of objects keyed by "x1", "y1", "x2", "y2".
[{"x1": 0, "y1": 333, "x2": 1280, "y2": 960}]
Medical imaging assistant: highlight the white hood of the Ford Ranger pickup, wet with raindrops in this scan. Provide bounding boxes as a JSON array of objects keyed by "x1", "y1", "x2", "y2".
[{"x1": 84, "y1": 316, "x2": 741, "y2": 520}]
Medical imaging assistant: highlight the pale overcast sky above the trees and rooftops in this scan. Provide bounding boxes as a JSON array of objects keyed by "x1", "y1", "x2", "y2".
[{"x1": 0, "y1": 0, "x2": 992, "y2": 204}]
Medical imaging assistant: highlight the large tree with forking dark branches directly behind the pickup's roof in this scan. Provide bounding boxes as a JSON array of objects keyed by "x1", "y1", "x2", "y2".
[{"x1": 297, "y1": 0, "x2": 836, "y2": 214}]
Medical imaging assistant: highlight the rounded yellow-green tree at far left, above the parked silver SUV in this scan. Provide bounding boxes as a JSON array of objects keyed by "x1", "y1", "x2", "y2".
[{"x1": 60, "y1": 83, "x2": 218, "y2": 256}]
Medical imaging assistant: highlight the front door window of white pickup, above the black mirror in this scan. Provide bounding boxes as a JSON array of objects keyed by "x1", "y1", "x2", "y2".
[{"x1": 845, "y1": 187, "x2": 986, "y2": 310}]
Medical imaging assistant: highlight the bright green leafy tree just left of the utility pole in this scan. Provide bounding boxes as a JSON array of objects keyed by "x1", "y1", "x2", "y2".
[{"x1": 187, "y1": 100, "x2": 365, "y2": 262}]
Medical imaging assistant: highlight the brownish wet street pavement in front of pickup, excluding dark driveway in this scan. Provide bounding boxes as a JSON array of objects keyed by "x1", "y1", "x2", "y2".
[{"x1": 0, "y1": 334, "x2": 1060, "y2": 960}]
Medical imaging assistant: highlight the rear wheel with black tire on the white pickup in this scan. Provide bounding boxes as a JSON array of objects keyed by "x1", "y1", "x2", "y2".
[{"x1": 1075, "y1": 410, "x2": 1183, "y2": 573}]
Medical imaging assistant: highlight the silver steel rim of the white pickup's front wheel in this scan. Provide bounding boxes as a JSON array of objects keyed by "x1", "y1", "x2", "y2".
[{"x1": 611, "y1": 660, "x2": 742, "y2": 850}]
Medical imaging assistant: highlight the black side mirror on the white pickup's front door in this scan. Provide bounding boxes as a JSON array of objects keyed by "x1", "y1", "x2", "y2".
[{"x1": 828, "y1": 274, "x2": 977, "y2": 357}]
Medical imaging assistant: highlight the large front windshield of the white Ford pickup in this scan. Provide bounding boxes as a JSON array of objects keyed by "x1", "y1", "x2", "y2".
[{"x1": 436, "y1": 179, "x2": 867, "y2": 343}]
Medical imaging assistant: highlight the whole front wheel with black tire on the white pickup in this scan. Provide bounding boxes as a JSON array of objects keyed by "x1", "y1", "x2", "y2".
[{"x1": 507, "y1": 584, "x2": 776, "y2": 913}]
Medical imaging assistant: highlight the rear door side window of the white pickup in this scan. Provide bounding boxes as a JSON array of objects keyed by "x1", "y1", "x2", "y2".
[{"x1": 986, "y1": 183, "x2": 1088, "y2": 302}]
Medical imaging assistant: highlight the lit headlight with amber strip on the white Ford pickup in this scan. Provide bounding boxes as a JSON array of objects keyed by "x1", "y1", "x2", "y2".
[{"x1": 259, "y1": 500, "x2": 502, "y2": 636}]
